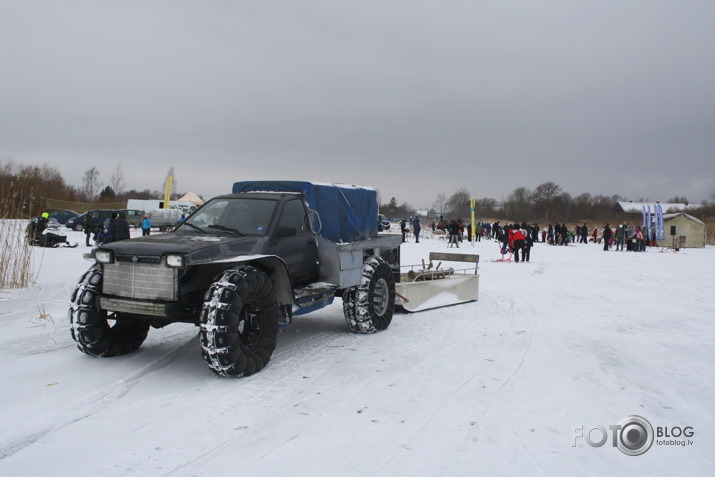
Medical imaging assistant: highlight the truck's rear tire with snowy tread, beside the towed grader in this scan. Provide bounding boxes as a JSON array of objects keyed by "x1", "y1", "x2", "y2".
[{"x1": 343, "y1": 256, "x2": 395, "y2": 333}]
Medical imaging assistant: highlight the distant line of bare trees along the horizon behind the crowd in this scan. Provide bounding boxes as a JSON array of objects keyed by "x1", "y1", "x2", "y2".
[{"x1": 0, "y1": 161, "x2": 715, "y2": 224}]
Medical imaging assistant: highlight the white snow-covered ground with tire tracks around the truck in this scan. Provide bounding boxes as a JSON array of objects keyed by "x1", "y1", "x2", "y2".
[{"x1": 0, "y1": 226, "x2": 715, "y2": 477}]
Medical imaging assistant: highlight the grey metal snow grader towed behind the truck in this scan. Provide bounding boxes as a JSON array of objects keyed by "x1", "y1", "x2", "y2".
[{"x1": 395, "y1": 252, "x2": 479, "y2": 312}]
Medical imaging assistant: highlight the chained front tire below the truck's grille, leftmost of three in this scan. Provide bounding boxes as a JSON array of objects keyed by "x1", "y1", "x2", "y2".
[{"x1": 68, "y1": 264, "x2": 149, "y2": 357}]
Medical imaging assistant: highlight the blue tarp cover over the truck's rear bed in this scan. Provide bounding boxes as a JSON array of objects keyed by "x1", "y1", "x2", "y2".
[{"x1": 233, "y1": 181, "x2": 377, "y2": 243}]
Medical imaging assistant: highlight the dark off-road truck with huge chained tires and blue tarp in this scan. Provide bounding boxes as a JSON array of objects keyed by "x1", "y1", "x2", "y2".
[{"x1": 68, "y1": 181, "x2": 402, "y2": 377}]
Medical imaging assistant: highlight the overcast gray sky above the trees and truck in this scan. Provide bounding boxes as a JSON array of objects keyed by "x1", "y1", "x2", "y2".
[{"x1": 0, "y1": 0, "x2": 715, "y2": 208}]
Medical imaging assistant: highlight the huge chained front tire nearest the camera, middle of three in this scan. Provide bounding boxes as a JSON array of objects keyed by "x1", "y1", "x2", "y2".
[{"x1": 199, "y1": 265, "x2": 280, "y2": 377}]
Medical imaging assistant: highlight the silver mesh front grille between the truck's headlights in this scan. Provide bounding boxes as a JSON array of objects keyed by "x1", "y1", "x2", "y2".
[{"x1": 103, "y1": 260, "x2": 178, "y2": 301}]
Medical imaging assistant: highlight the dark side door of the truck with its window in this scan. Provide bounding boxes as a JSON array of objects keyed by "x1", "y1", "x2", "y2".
[{"x1": 269, "y1": 198, "x2": 318, "y2": 285}]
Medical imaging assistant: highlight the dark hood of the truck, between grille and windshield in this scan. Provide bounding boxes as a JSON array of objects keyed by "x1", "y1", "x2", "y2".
[{"x1": 99, "y1": 232, "x2": 268, "y2": 265}]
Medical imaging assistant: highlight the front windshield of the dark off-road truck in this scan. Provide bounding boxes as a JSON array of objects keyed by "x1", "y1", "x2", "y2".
[{"x1": 179, "y1": 198, "x2": 278, "y2": 235}]
